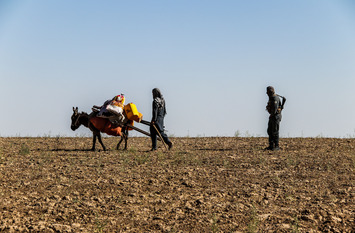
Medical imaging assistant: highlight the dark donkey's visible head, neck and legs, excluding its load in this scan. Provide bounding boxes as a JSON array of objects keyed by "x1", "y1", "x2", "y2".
[{"x1": 71, "y1": 107, "x2": 128, "y2": 151}]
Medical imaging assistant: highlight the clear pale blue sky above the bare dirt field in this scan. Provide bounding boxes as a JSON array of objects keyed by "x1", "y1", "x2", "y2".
[{"x1": 0, "y1": 0, "x2": 355, "y2": 137}]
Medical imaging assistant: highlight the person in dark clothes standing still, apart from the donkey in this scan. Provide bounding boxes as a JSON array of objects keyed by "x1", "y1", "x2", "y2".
[{"x1": 265, "y1": 86, "x2": 286, "y2": 150}]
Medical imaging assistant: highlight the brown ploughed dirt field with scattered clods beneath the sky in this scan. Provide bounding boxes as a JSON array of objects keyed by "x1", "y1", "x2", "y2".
[{"x1": 0, "y1": 137, "x2": 355, "y2": 232}]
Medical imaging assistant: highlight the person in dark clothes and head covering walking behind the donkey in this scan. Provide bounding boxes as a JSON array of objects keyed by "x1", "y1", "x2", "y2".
[{"x1": 150, "y1": 88, "x2": 173, "y2": 151}]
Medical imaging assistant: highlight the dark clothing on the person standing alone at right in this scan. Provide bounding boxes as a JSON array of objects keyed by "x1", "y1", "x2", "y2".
[{"x1": 266, "y1": 95, "x2": 282, "y2": 148}]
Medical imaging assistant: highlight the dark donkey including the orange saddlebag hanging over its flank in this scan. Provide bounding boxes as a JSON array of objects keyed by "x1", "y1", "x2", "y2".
[{"x1": 71, "y1": 107, "x2": 128, "y2": 150}]
